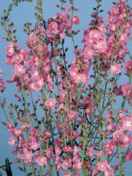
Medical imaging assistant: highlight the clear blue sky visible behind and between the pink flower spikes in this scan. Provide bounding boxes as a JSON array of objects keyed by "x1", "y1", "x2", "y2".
[{"x1": 0, "y1": 0, "x2": 132, "y2": 176}]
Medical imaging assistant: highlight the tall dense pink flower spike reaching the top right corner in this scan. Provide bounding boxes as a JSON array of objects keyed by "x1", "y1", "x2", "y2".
[{"x1": 106, "y1": 0, "x2": 131, "y2": 59}]
